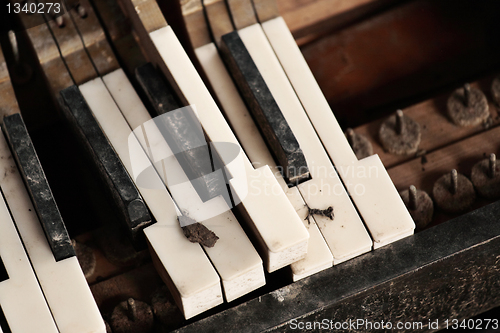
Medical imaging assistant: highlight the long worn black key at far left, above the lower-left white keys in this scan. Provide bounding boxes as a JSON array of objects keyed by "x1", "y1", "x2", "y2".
[{"x1": 2, "y1": 113, "x2": 75, "y2": 261}]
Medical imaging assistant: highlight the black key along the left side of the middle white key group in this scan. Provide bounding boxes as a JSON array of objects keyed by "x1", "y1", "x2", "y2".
[{"x1": 60, "y1": 86, "x2": 153, "y2": 248}]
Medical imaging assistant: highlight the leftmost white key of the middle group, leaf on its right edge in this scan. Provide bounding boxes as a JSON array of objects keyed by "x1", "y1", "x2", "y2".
[{"x1": 79, "y1": 78, "x2": 223, "y2": 319}]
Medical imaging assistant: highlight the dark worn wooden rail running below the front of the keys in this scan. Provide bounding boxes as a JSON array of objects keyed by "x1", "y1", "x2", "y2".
[{"x1": 177, "y1": 201, "x2": 500, "y2": 332}]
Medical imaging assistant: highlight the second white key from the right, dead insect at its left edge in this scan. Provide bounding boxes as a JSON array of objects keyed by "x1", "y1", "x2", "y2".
[{"x1": 238, "y1": 24, "x2": 372, "y2": 264}]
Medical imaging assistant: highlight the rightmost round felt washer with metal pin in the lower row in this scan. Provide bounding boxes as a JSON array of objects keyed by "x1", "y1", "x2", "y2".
[{"x1": 471, "y1": 154, "x2": 500, "y2": 199}]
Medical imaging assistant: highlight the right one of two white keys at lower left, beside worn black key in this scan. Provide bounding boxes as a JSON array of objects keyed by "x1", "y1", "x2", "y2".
[{"x1": 0, "y1": 128, "x2": 106, "y2": 333}]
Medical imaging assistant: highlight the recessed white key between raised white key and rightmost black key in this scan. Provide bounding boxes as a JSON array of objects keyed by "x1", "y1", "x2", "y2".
[{"x1": 195, "y1": 43, "x2": 333, "y2": 281}]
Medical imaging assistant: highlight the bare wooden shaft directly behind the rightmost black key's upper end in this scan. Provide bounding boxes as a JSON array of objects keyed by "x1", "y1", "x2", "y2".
[{"x1": 203, "y1": 0, "x2": 234, "y2": 46}]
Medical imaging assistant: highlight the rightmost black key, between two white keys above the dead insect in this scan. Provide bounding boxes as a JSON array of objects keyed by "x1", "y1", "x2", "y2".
[{"x1": 221, "y1": 31, "x2": 309, "y2": 184}]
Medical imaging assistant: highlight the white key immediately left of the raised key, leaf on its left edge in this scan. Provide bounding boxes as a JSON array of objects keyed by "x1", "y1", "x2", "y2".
[{"x1": 98, "y1": 70, "x2": 265, "y2": 301}]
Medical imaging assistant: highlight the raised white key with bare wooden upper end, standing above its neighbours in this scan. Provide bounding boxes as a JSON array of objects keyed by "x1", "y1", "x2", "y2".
[{"x1": 117, "y1": 0, "x2": 309, "y2": 272}]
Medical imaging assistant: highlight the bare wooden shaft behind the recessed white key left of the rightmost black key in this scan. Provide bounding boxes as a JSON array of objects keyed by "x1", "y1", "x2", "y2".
[{"x1": 180, "y1": 0, "x2": 212, "y2": 49}]
